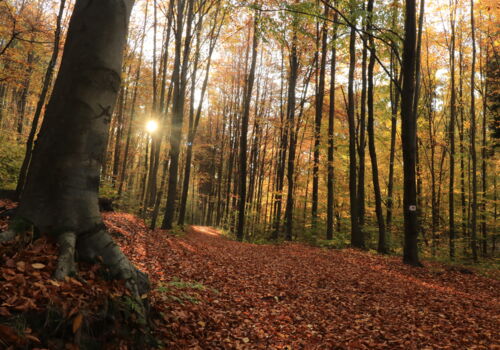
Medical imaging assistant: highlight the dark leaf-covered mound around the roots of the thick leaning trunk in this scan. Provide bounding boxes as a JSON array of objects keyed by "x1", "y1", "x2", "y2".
[{"x1": 0, "y1": 206, "x2": 154, "y2": 350}]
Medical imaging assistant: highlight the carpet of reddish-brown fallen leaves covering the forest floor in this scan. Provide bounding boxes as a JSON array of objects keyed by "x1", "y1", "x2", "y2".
[{"x1": 0, "y1": 206, "x2": 500, "y2": 349}]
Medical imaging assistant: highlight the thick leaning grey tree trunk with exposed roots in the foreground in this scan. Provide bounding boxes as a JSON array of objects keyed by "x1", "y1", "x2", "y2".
[{"x1": 5, "y1": 0, "x2": 146, "y2": 293}]
